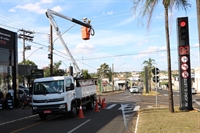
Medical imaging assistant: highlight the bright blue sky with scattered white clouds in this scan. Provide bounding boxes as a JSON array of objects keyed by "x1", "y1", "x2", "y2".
[{"x1": 0, "y1": 0, "x2": 199, "y2": 72}]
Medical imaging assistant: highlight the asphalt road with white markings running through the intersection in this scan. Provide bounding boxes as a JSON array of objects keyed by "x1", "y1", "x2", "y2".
[{"x1": 0, "y1": 90, "x2": 200, "y2": 133}]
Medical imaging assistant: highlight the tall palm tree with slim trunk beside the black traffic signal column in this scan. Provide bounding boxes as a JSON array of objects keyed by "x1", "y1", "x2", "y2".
[{"x1": 132, "y1": 0, "x2": 191, "y2": 113}]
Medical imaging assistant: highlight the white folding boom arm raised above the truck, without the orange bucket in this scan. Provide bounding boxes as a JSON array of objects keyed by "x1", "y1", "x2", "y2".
[{"x1": 46, "y1": 9, "x2": 92, "y2": 74}]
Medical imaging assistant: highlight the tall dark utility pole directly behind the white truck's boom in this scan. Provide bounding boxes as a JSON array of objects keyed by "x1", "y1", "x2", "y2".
[{"x1": 50, "y1": 24, "x2": 53, "y2": 76}]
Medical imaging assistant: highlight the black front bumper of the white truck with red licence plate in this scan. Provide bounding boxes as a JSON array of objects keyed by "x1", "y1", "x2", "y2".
[{"x1": 32, "y1": 104, "x2": 68, "y2": 115}]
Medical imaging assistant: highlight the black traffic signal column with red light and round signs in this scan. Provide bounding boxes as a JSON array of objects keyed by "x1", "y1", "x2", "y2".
[{"x1": 177, "y1": 17, "x2": 193, "y2": 111}]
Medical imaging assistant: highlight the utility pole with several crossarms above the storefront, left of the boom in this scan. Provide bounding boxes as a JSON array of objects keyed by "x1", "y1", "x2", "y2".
[{"x1": 18, "y1": 29, "x2": 34, "y2": 65}]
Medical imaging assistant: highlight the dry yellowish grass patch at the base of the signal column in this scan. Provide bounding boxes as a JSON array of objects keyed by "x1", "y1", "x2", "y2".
[{"x1": 132, "y1": 108, "x2": 200, "y2": 133}]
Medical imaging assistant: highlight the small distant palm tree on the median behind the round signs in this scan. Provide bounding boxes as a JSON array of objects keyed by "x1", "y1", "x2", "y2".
[{"x1": 142, "y1": 58, "x2": 156, "y2": 91}]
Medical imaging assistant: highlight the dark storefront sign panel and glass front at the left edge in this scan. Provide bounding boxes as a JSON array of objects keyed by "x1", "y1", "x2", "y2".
[{"x1": 0, "y1": 28, "x2": 18, "y2": 106}]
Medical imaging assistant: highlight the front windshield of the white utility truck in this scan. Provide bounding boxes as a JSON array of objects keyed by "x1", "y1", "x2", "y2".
[{"x1": 33, "y1": 80, "x2": 64, "y2": 94}]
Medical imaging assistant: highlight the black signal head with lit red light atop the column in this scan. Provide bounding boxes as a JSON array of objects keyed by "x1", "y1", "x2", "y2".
[{"x1": 177, "y1": 17, "x2": 189, "y2": 46}]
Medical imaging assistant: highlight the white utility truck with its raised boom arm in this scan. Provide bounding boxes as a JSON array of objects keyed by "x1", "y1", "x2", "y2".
[{"x1": 32, "y1": 9, "x2": 97, "y2": 120}]
